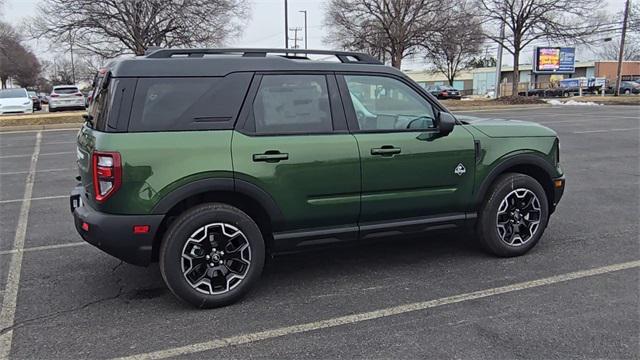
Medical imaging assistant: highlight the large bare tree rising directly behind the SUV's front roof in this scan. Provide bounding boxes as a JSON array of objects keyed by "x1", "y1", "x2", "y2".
[{"x1": 325, "y1": 0, "x2": 450, "y2": 69}]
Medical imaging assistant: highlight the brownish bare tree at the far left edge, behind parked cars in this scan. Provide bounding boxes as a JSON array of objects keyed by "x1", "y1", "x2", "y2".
[{"x1": 0, "y1": 22, "x2": 40, "y2": 89}]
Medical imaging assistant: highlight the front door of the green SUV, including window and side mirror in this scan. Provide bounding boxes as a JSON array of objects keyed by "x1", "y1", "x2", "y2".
[{"x1": 338, "y1": 74, "x2": 475, "y2": 225}]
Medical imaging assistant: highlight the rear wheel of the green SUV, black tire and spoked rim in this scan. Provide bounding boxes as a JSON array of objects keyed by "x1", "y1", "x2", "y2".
[{"x1": 160, "y1": 203, "x2": 265, "y2": 308}]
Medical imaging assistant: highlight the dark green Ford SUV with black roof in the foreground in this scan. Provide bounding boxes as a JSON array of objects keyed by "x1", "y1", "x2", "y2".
[{"x1": 70, "y1": 49, "x2": 564, "y2": 307}]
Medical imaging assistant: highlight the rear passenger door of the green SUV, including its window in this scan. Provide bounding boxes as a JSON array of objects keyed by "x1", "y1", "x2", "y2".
[{"x1": 232, "y1": 73, "x2": 360, "y2": 243}]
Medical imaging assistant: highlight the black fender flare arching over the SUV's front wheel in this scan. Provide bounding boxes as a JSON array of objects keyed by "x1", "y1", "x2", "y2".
[{"x1": 474, "y1": 154, "x2": 556, "y2": 214}]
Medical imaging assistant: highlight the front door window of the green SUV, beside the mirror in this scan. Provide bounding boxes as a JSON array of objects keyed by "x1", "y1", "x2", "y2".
[{"x1": 344, "y1": 75, "x2": 435, "y2": 131}]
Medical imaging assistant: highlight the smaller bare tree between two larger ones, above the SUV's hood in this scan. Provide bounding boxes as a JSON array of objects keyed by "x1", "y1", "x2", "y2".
[{"x1": 421, "y1": 2, "x2": 485, "y2": 85}]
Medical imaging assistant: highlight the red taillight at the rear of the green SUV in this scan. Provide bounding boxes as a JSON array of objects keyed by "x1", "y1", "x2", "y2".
[{"x1": 92, "y1": 151, "x2": 122, "y2": 202}]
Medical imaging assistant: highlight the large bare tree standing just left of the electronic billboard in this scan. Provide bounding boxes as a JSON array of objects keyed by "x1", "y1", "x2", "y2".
[{"x1": 479, "y1": 0, "x2": 602, "y2": 94}]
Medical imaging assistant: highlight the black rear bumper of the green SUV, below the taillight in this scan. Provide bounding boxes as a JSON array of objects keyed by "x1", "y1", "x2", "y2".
[{"x1": 69, "y1": 186, "x2": 163, "y2": 266}]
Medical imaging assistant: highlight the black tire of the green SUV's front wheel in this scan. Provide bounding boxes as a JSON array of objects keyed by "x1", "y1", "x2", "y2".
[{"x1": 476, "y1": 173, "x2": 549, "y2": 257}]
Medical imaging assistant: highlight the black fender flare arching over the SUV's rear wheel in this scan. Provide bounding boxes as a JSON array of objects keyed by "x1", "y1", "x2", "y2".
[{"x1": 152, "y1": 178, "x2": 284, "y2": 224}]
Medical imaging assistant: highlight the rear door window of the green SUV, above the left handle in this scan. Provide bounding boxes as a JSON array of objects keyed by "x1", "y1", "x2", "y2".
[{"x1": 251, "y1": 75, "x2": 333, "y2": 134}]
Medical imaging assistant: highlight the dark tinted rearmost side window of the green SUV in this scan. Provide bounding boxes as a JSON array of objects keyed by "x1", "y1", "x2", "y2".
[{"x1": 129, "y1": 73, "x2": 252, "y2": 132}]
